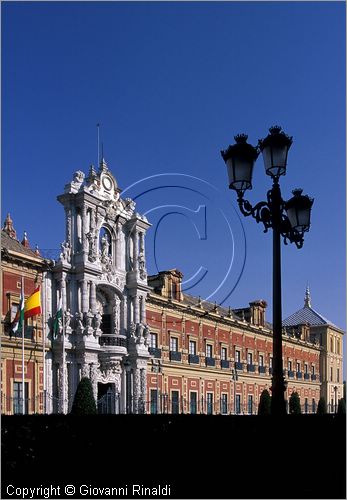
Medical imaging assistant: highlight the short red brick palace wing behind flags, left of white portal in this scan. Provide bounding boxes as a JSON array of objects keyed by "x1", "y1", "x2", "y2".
[{"x1": 1, "y1": 215, "x2": 48, "y2": 414}]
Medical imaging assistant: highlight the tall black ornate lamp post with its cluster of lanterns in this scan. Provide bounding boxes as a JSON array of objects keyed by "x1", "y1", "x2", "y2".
[{"x1": 221, "y1": 126, "x2": 313, "y2": 415}]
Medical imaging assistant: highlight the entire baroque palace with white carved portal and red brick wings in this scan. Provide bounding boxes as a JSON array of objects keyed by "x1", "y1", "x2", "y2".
[{"x1": 1, "y1": 160, "x2": 344, "y2": 414}]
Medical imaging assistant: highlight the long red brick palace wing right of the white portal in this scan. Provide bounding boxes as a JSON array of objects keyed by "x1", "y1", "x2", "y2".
[{"x1": 146, "y1": 270, "x2": 322, "y2": 414}]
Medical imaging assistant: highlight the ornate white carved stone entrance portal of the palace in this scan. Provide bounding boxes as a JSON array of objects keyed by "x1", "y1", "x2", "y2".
[{"x1": 47, "y1": 159, "x2": 150, "y2": 413}]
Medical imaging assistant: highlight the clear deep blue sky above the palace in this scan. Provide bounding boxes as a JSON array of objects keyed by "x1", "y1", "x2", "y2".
[{"x1": 2, "y1": 2, "x2": 346, "y2": 336}]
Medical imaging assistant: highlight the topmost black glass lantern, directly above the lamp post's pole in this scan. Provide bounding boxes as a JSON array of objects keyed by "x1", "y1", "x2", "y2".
[{"x1": 258, "y1": 125, "x2": 293, "y2": 178}]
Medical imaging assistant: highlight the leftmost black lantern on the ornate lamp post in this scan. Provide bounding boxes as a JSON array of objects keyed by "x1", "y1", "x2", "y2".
[{"x1": 221, "y1": 134, "x2": 259, "y2": 193}]
